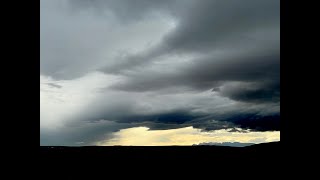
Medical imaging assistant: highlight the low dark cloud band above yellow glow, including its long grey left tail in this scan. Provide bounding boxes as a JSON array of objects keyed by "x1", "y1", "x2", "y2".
[{"x1": 71, "y1": 101, "x2": 280, "y2": 131}]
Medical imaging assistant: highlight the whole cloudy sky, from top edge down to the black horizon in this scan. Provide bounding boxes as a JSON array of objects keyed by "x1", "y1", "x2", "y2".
[{"x1": 40, "y1": 0, "x2": 280, "y2": 146}]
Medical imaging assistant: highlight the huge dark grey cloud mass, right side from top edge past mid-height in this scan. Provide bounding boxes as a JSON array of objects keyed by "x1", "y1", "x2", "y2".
[{"x1": 99, "y1": 0, "x2": 280, "y2": 102}]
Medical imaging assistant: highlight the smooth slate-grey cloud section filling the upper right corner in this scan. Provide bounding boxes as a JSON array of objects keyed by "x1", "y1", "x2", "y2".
[{"x1": 161, "y1": 0, "x2": 280, "y2": 51}]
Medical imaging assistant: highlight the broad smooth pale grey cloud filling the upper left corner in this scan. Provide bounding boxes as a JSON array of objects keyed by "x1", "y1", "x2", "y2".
[{"x1": 40, "y1": 0, "x2": 176, "y2": 79}]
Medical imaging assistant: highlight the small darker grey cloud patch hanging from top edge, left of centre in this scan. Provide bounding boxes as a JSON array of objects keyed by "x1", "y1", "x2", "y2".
[{"x1": 68, "y1": 0, "x2": 185, "y2": 23}]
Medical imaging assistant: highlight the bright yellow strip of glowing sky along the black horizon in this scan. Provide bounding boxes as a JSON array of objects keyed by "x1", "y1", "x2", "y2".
[{"x1": 96, "y1": 127, "x2": 280, "y2": 146}]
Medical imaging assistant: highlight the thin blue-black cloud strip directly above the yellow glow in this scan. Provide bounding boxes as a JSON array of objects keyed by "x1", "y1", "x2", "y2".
[{"x1": 120, "y1": 112, "x2": 280, "y2": 133}]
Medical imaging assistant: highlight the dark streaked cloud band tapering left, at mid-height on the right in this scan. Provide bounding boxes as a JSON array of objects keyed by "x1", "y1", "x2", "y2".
[{"x1": 113, "y1": 48, "x2": 280, "y2": 102}]
